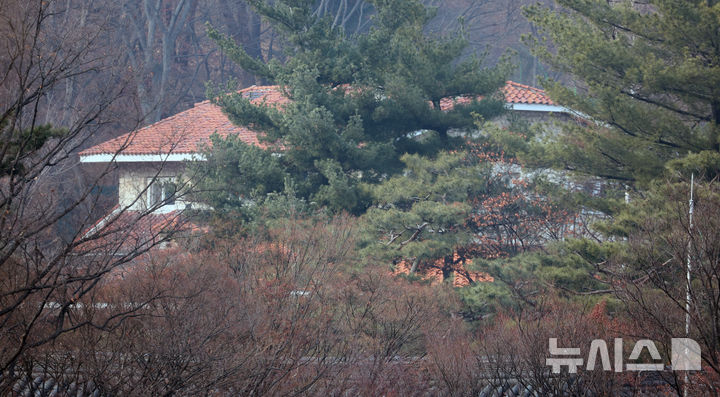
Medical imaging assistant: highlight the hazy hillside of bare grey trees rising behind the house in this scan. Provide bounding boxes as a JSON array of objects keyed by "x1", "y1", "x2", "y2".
[{"x1": 5, "y1": 0, "x2": 543, "y2": 138}]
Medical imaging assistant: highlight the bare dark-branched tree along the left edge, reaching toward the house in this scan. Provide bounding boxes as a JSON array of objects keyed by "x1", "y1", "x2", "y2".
[{"x1": 0, "y1": 0, "x2": 188, "y2": 394}]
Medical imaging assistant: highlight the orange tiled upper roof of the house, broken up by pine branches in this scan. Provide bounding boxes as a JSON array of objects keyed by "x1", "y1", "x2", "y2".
[{"x1": 80, "y1": 81, "x2": 554, "y2": 156}]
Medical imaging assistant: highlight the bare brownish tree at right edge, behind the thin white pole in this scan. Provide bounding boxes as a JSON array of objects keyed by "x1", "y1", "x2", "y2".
[{"x1": 610, "y1": 178, "x2": 720, "y2": 395}]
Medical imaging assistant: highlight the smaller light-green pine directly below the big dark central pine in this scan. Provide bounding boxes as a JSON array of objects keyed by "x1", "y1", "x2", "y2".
[{"x1": 363, "y1": 153, "x2": 492, "y2": 278}]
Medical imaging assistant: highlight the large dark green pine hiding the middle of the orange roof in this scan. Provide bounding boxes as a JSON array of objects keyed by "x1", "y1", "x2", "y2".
[{"x1": 210, "y1": 0, "x2": 510, "y2": 212}]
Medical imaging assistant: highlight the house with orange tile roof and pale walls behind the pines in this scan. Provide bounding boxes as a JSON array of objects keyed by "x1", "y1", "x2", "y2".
[{"x1": 79, "y1": 81, "x2": 571, "y2": 234}]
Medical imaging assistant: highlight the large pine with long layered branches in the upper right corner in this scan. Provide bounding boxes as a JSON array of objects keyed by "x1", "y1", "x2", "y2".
[{"x1": 525, "y1": 0, "x2": 720, "y2": 186}]
